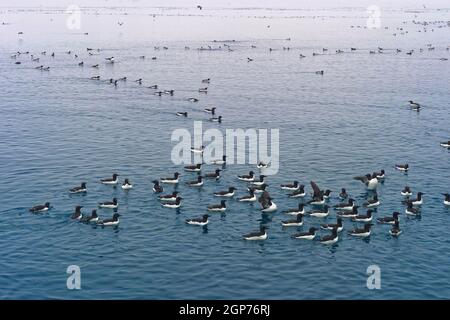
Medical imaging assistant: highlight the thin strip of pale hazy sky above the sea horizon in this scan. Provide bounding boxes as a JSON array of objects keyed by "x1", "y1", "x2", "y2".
[{"x1": 0, "y1": 0, "x2": 450, "y2": 9}]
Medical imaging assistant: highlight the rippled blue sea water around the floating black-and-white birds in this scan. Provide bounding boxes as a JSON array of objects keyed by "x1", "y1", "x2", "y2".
[{"x1": 0, "y1": 8, "x2": 450, "y2": 299}]
